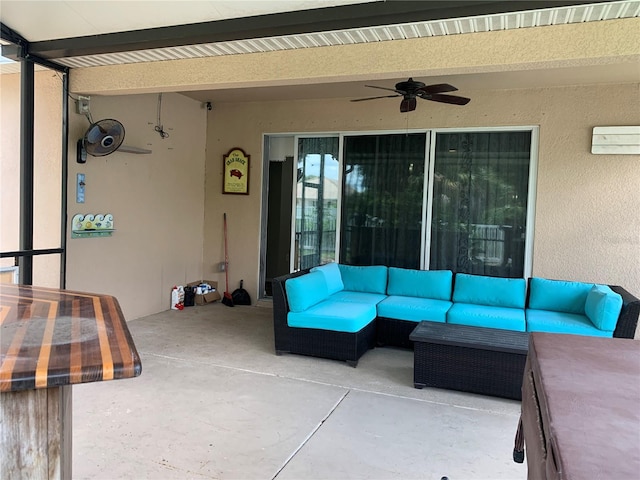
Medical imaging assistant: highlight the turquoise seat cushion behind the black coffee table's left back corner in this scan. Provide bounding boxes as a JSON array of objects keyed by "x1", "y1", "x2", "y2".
[{"x1": 378, "y1": 295, "x2": 453, "y2": 322}]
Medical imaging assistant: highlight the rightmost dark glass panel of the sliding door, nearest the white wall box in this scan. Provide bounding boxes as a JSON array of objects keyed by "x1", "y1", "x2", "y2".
[{"x1": 428, "y1": 130, "x2": 532, "y2": 277}]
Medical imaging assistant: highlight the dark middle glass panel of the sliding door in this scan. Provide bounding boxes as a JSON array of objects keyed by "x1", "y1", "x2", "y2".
[{"x1": 340, "y1": 133, "x2": 426, "y2": 268}]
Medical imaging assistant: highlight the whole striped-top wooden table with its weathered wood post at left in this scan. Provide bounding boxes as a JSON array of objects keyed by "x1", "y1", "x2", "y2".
[{"x1": 0, "y1": 284, "x2": 142, "y2": 479}]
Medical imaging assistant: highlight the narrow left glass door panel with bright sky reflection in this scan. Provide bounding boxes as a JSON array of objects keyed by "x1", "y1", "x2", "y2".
[{"x1": 292, "y1": 137, "x2": 339, "y2": 271}]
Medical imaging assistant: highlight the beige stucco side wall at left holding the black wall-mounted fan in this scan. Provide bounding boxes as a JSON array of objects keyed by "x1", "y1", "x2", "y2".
[{"x1": 67, "y1": 94, "x2": 206, "y2": 319}]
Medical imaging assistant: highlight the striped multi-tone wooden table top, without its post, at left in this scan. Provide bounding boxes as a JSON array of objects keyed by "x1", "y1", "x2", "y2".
[{"x1": 0, "y1": 284, "x2": 142, "y2": 392}]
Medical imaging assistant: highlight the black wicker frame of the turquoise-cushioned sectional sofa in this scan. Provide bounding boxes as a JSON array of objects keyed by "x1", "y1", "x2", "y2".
[{"x1": 272, "y1": 269, "x2": 640, "y2": 367}]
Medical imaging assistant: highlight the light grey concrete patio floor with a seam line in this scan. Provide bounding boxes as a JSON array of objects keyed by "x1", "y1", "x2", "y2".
[{"x1": 73, "y1": 301, "x2": 527, "y2": 480}]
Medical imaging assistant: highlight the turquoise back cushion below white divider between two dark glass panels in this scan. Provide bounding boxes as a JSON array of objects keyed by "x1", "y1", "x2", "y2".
[{"x1": 387, "y1": 267, "x2": 453, "y2": 300}]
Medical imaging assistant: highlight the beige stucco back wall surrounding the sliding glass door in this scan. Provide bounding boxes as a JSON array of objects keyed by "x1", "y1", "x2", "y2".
[{"x1": 204, "y1": 84, "x2": 640, "y2": 296}]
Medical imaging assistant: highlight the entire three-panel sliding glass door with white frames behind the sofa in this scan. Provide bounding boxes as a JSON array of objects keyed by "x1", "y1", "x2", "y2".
[{"x1": 280, "y1": 127, "x2": 537, "y2": 278}]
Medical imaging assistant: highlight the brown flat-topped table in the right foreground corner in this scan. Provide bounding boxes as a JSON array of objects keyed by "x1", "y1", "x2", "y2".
[{"x1": 514, "y1": 332, "x2": 640, "y2": 480}]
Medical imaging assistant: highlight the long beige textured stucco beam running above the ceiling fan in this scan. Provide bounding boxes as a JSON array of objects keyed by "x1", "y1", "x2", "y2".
[{"x1": 71, "y1": 18, "x2": 640, "y2": 94}]
